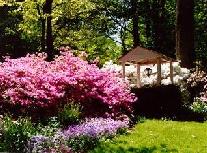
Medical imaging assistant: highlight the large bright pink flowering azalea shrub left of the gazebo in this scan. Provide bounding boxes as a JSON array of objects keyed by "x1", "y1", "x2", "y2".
[{"x1": 0, "y1": 48, "x2": 135, "y2": 113}]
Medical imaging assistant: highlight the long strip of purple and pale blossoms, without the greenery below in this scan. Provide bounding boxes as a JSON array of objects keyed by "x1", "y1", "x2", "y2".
[{"x1": 28, "y1": 118, "x2": 128, "y2": 152}]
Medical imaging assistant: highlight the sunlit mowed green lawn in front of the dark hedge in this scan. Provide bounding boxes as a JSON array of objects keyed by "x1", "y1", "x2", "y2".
[{"x1": 90, "y1": 120, "x2": 207, "y2": 153}]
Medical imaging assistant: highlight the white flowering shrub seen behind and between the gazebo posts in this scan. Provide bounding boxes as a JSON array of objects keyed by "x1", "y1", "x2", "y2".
[{"x1": 102, "y1": 61, "x2": 190, "y2": 86}]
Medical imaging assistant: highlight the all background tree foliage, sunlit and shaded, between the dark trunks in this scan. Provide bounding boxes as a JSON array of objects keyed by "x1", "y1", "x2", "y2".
[{"x1": 0, "y1": 0, "x2": 207, "y2": 68}]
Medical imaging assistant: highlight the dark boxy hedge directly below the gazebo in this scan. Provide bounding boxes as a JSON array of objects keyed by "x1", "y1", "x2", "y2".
[{"x1": 132, "y1": 85, "x2": 183, "y2": 120}]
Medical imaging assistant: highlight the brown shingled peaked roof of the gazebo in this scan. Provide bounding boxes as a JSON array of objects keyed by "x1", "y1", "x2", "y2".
[{"x1": 119, "y1": 46, "x2": 175, "y2": 64}]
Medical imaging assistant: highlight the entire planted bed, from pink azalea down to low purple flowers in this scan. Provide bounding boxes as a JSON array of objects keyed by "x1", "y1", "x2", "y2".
[{"x1": 0, "y1": 48, "x2": 136, "y2": 153}]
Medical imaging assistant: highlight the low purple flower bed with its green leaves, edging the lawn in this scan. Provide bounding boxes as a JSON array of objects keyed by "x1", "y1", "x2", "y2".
[{"x1": 28, "y1": 118, "x2": 128, "y2": 152}]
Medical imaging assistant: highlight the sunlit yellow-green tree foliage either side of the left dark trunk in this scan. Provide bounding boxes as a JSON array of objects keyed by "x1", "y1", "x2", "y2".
[{"x1": 19, "y1": 0, "x2": 121, "y2": 64}]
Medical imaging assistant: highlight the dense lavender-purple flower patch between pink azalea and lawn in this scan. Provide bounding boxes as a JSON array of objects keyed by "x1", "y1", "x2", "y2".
[{"x1": 62, "y1": 118, "x2": 128, "y2": 138}]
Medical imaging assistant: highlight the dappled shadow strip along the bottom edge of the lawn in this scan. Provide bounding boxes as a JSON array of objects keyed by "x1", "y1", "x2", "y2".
[{"x1": 90, "y1": 144, "x2": 178, "y2": 153}]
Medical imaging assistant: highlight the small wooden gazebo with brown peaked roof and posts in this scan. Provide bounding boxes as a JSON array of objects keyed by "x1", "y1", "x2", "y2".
[{"x1": 119, "y1": 46, "x2": 175, "y2": 88}]
